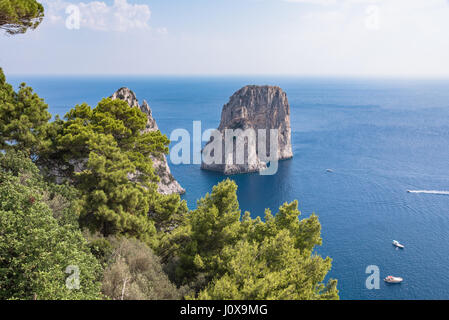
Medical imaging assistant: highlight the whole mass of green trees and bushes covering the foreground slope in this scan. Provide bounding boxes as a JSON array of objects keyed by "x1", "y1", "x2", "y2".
[{"x1": 0, "y1": 69, "x2": 338, "y2": 299}]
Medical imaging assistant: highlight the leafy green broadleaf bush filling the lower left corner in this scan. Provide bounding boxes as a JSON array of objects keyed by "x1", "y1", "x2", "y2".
[{"x1": 0, "y1": 152, "x2": 101, "y2": 299}]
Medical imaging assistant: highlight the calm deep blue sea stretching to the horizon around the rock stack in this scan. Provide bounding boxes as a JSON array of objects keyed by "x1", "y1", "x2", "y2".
[{"x1": 8, "y1": 76, "x2": 449, "y2": 299}]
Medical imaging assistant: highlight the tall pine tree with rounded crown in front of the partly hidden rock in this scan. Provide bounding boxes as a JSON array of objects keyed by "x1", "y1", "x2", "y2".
[{"x1": 44, "y1": 99, "x2": 179, "y2": 242}]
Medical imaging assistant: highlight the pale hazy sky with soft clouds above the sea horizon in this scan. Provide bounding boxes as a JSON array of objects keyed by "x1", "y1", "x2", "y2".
[{"x1": 0, "y1": 0, "x2": 449, "y2": 77}]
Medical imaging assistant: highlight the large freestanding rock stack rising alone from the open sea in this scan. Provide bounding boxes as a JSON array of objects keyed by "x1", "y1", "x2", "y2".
[{"x1": 201, "y1": 86, "x2": 293, "y2": 174}]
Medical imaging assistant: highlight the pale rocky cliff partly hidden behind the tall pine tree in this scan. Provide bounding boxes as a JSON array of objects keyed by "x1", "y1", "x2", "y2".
[{"x1": 111, "y1": 88, "x2": 185, "y2": 194}]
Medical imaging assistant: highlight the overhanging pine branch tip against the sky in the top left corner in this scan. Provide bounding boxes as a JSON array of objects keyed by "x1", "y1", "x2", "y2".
[{"x1": 0, "y1": 0, "x2": 44, "y2": 34}]
